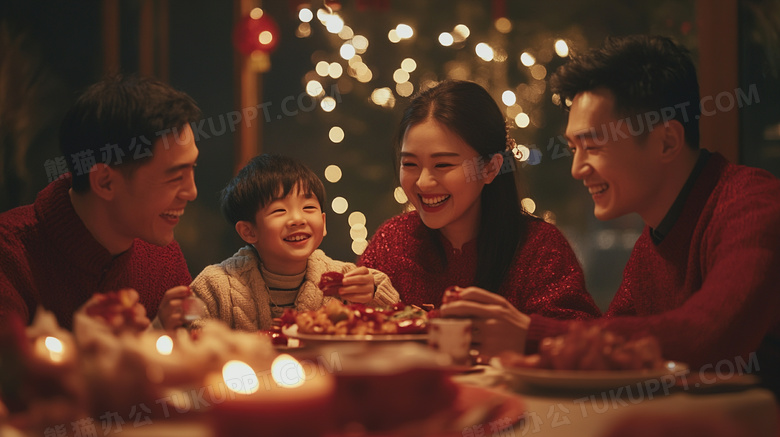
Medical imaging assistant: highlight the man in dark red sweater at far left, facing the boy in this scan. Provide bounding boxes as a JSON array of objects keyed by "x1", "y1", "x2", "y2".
[{"x1": 0, "y1": 76, "x2": 200, "y2": 328}]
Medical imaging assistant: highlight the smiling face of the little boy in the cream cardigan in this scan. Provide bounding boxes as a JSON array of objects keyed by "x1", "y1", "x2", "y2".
[{"x1": 236, "y1": 186, "x2": 327, "y2": 275}]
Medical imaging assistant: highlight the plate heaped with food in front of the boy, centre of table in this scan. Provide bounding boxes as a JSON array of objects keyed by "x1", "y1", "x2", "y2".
[{"x1": 281, "y1": 299, "x2": 428, "y2": 342}]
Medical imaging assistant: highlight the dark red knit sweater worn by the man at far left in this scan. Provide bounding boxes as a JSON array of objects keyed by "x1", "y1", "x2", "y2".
[{"x1": 0, "y1": 177, "x2": 192, "y2": 329}]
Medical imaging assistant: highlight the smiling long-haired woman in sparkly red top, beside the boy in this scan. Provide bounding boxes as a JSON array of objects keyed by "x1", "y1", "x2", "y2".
[{"x1": 359, "y1": 81, "x2": 600, "y2": 350}]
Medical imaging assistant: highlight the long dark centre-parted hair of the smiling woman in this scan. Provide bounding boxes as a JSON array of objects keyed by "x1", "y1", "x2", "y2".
[{"x1": 395, "y1": 80, "x2": 528, "y2": 293}]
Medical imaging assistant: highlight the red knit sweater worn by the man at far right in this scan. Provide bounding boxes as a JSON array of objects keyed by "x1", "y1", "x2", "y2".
[{"x1": 528, "y1": 154, "x2": 780, "y2": 370}]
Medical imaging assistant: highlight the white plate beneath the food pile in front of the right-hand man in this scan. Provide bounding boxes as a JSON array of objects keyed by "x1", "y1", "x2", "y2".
[{"x1": 491, "y1": 359, "x2": 688, "y2": 390}]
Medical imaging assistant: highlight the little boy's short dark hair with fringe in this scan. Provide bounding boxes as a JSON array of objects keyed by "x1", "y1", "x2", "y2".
[{"x1": 220, "y1": 154, "x2": 325, "y2": 225}]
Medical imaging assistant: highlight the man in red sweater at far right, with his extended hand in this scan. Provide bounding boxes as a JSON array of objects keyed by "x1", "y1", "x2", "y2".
[{"x1": 442, "y1": 36, "x2": 780, "y2": 384}]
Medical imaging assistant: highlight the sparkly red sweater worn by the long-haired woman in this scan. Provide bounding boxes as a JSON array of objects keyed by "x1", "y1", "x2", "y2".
[{"x1": 358, "y1": 211, "x2": 600, "y2": 319}]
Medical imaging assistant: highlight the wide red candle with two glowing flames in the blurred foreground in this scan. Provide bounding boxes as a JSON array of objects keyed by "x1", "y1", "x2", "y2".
[{"x1": 209, "y1": 355, "x2": 335, "y2": 436}]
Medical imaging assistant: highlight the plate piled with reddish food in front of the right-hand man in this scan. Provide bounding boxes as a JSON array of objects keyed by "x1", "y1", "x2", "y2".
[{"x1": 491, "y1": 323, "x2": 689, "y2": 390}]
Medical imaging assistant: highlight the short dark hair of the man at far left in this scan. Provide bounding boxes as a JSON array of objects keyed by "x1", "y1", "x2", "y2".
[{"x1": 60, "y1": 75, "x2": 201, "y2": 193}]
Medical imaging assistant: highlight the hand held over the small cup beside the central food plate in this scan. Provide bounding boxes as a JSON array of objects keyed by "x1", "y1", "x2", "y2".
[{"x1": 441, "y1": 287, "x2": 531, "y2": 356}]
